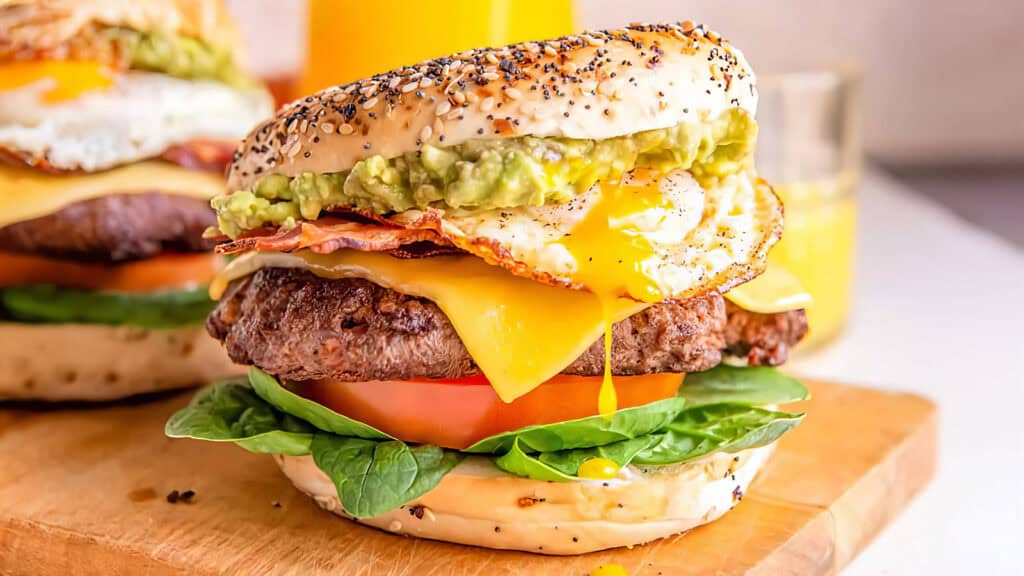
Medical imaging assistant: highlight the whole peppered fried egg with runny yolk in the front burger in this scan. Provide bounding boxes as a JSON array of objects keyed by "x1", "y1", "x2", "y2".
[{"x1": 389, "y1": 167, "x2": 782, "y2": 302}]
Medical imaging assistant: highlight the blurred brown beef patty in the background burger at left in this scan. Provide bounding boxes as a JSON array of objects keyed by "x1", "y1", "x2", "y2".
[{"x1": 0, "y1": 193, "x2": 217, "y2": 262}]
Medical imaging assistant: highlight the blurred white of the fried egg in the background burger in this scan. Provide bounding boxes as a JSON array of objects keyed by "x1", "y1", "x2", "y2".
[{"x1": 0, "y1": 72, "x2": 272, "y2": 171}]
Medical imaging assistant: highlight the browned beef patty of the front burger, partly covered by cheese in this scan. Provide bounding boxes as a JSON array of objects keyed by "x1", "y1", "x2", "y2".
[{"x1": 207, "y1": 269, "x2": 807, "y2": 381}]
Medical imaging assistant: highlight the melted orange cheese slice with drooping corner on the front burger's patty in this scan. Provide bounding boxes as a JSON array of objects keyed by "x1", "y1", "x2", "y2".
[{"x1": 210, "y1": 250, "x2": 649, "y2": 402}]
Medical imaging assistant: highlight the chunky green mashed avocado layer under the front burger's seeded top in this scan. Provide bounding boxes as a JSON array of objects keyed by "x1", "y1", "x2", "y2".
[{"x1": 212, "y1": 109, "x2": 757, "y2": 238}]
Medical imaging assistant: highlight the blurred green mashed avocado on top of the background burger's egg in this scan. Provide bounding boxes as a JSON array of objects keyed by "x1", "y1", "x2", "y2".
[{"x1": 104, "y1": 28, "x2": 248, "y2": 85}]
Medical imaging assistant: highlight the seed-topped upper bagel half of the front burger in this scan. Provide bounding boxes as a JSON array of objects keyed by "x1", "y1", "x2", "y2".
[{"x1": 228, "y1": 22, "x2": 757, "y2": 191}]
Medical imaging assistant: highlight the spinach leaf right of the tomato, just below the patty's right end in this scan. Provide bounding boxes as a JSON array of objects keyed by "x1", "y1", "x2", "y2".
[{"x1": 678, "y1": 364, "x2": 810, "y2": 407}]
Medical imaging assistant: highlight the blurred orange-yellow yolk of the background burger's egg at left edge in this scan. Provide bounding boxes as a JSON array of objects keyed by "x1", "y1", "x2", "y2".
[{"x1": 0, "y1": 60, "x2": 114, "y2": 104}]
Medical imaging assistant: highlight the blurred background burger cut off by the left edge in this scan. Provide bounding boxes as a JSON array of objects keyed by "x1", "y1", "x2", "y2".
[{"x1": 0, "y1": 0, "x2": 272, "y2": 400}]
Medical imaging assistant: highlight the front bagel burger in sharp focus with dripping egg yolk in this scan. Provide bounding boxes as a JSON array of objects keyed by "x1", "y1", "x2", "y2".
[{"x1": 166, "y1": 22, "x2": 807, "y2": 554}]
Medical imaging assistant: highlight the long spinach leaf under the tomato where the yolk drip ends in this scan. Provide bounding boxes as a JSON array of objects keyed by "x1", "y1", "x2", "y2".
[{"x1": 463, "y1": 398, "x2": 685, "y2": 454}]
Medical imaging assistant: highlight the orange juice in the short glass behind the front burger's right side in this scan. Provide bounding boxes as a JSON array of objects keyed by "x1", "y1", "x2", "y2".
[{"x1": 768, "y1": 175, "x2": 857, "y2": 347}]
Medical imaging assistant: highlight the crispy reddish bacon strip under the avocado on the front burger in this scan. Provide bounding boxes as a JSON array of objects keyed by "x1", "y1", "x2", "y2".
[{"x1": 217, "y1": 218, "x2": 458, "y2": 258}]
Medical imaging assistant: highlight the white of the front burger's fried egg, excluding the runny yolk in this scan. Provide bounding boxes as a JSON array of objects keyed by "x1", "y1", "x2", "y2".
[{"x1": 396, "y1": 170, "x2": 782, "y2": 297}]
